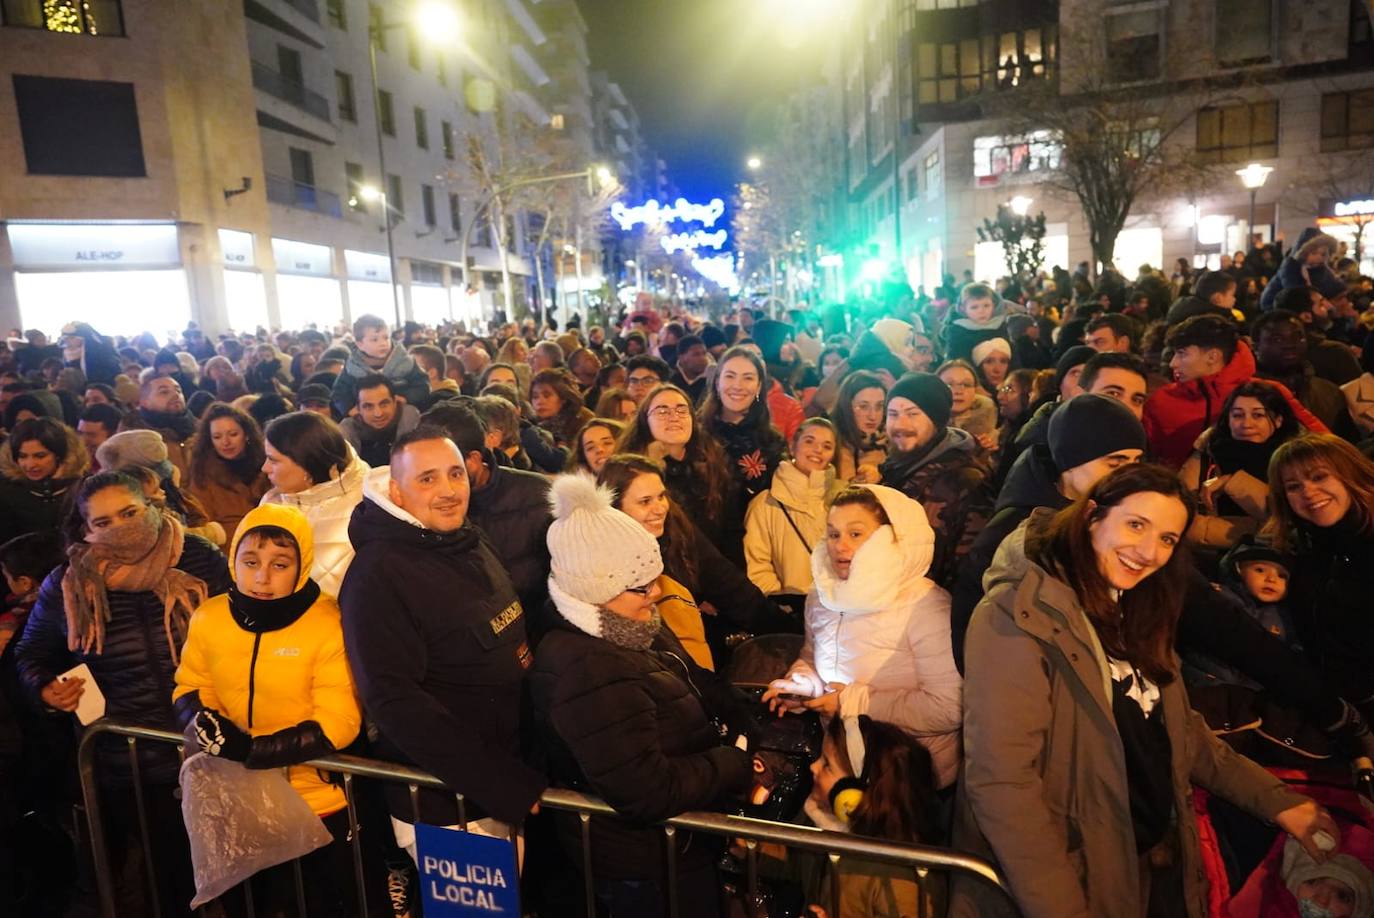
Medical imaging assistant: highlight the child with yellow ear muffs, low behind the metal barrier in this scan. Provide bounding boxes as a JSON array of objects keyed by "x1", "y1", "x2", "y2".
[{"x1": 805, "y1": 715, "x2": 948, "y2": 918}]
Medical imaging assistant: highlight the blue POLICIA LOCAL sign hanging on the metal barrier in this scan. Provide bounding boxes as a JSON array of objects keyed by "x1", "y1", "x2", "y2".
[{"x1": 415, "y1": 823, "x2": 521, "y2": 918}]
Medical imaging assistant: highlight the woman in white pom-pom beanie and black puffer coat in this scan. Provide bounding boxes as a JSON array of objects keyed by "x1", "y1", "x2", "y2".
[{"x1": 530, "y1": 473, "x2": 754, "y2": 918}]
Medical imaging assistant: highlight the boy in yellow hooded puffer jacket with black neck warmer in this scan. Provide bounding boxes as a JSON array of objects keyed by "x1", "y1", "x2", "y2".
[{"x1": 172, "y1": 504, "x2": 363, "y2": 915}]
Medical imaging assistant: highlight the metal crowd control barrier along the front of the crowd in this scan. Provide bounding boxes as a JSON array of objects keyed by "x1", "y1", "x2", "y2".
[{"x1": 77, "y1": 720, "x2": 1010, "y2": 918}]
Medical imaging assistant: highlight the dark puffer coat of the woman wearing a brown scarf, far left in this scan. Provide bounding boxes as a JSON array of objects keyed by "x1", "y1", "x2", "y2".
[{"x1": 15, "y1": 533, "x2": 229, "y2": 785}]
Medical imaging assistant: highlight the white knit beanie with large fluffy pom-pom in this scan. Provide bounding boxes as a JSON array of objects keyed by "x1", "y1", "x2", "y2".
[{"x1": 548, "y1": 471, "x2": 664, "y2": 615}]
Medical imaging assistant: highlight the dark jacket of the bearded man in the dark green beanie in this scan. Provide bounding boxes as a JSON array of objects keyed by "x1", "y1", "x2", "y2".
[{"x1": 881, "y1": 427, "x2": 992, "y2": 584}]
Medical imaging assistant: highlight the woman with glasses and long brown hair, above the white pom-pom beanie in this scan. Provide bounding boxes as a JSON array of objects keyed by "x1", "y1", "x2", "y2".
[{"x1": 616, "y1": 382, "x2": 743, "y2": 558}]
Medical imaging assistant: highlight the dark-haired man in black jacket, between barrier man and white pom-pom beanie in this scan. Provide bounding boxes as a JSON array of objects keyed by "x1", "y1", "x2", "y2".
[{"x1": 423, "y1": 404, "x2": 554, "y2": 643}]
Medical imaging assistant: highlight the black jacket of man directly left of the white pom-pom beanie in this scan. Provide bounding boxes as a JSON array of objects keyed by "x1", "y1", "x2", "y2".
[{"x1": 467, "y1": 458, "x2": 554, "y2": 639}]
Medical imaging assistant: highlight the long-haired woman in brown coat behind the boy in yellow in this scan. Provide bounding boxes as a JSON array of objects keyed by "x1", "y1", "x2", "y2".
[{"x1": 187, "y1": 401, "x2": 272, "y2": 535}]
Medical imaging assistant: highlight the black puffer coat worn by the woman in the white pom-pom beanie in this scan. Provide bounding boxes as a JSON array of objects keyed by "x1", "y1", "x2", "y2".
[{"x1": 529, "y1": 621, "x2": 753, "y2": 880}]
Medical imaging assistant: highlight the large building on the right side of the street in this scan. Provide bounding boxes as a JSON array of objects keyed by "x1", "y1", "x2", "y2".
[{"x1": 827, "y1": 0, "x2": 1374, "y2": 293}]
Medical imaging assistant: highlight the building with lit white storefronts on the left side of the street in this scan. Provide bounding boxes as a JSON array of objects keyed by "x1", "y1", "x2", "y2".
[{"x1": 0, "y1": 0, "x2": 610, "y2": 334}]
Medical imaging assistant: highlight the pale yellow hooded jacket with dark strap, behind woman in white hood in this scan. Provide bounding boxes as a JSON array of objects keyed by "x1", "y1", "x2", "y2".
[{"x1": 745, "y1": 459, "x2": 841, "y2": 595}]
